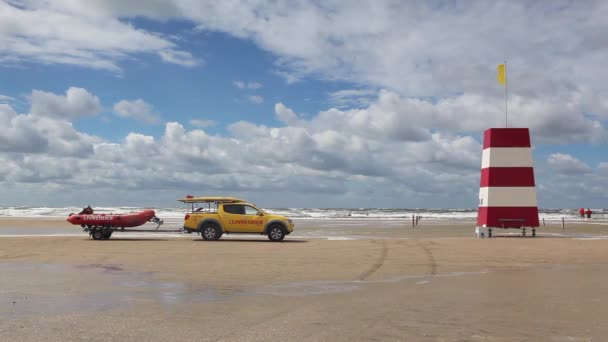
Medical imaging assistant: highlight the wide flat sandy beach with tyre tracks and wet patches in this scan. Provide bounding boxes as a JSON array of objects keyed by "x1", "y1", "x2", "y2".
[{"x1": 0, "y1": 220, "x2": 608, "y2": 341}]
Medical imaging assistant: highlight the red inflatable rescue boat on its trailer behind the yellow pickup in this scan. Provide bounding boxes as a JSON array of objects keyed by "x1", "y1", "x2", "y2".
[{"x1": 68, "y1": 207, "x2": 163, "y2": 240}]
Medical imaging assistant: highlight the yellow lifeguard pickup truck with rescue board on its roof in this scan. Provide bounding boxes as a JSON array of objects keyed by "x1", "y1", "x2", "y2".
[{"x1": 178, "y1": 196, "x2": 294, "y2": 241}]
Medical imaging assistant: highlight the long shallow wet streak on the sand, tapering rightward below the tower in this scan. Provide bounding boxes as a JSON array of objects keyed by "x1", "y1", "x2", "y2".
[{"x1": 0, "y1": 262, "x2": 496, "y2": 320}]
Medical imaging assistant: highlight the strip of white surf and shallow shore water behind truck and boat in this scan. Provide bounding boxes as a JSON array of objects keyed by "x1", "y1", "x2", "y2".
[{"x1": 0, "y1": 206, "x2": 608, "y2": 241}]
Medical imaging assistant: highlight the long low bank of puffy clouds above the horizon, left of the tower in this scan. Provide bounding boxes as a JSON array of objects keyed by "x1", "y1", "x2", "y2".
[{"x1": 0, "y1": 87, "x2": 481, "y2": 205}]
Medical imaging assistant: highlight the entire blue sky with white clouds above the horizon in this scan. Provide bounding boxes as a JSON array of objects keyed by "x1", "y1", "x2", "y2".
[{"x1": 0, "y1": 0, "x2": 608, "y2": 208}]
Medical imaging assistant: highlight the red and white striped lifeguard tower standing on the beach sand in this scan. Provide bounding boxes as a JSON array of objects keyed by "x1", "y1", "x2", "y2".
[{"x1": 477, "y1": 128, "x2": 539, "y2": 236}]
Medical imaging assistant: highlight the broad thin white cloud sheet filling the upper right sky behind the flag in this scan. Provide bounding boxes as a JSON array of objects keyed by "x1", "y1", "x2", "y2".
[{"x1": 179, "y1": 1, "x2": 608, "y2": 96}]
